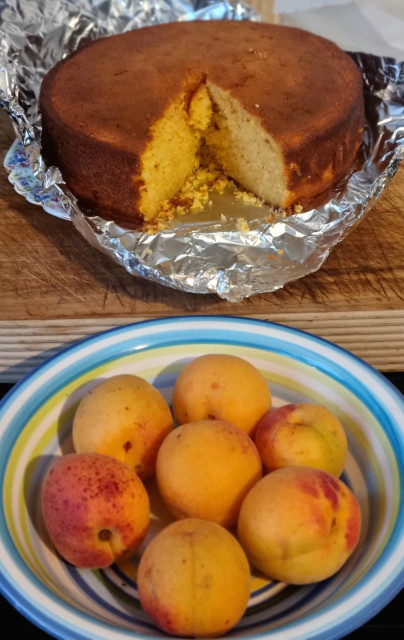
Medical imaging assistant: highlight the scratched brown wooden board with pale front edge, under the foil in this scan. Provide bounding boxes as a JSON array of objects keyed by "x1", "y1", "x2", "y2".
[{"x1": 0, "y1": 3, "x2": 404, "y2": 381}]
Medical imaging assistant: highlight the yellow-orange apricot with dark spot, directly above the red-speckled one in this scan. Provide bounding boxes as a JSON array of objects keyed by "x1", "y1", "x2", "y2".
[{"x1": 73, "y1": 374, "x2": 173, "y2": 480}]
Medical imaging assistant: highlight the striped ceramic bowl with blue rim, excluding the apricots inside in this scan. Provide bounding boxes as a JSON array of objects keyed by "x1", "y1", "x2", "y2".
[{"x1": 0, "y1": 316, "x2": 404, "y2": 640}]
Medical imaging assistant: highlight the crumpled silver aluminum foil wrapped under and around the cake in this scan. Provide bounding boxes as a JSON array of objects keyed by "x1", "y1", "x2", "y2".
[{"x1": 0, "y1": 0, "x2": 404, "y2": 302}]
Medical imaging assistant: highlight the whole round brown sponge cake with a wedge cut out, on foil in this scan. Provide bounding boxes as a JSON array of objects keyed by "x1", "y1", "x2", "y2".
[{"x1": 40, "y1": 20, "x2": 364, "y2": 224}]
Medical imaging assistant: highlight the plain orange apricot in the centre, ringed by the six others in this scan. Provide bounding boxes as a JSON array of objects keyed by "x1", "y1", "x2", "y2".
[{"x1": 156, "y1": 420, "x2": 262, "y2": 527}]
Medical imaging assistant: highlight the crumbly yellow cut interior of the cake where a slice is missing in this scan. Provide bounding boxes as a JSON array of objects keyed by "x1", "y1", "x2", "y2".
[{"x1": 136, "y1": 82, "x2": 286, "y2": 222}]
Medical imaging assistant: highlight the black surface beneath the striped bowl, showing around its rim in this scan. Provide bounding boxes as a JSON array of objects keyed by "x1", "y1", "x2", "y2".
[{"x1": 0, "y1": 373, "x2": 404, "y2": 640}]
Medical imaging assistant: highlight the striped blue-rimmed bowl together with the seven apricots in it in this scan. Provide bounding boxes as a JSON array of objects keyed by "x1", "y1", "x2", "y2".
[{"x1": 0, "y1": 316, "x2": 404, "y2": 640}]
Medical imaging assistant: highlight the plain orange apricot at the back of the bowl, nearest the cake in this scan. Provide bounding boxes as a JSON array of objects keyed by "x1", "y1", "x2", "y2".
[{"x1": 172, "y1": 354, "x2": 271, "y2": 435}]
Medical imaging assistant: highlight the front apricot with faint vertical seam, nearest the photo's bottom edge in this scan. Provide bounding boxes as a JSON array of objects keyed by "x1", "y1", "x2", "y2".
[{"x1": 137, "y1": 518, "x2": 251, "y2": 638}]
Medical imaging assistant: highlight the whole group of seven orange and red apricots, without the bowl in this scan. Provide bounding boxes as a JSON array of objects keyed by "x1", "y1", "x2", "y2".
[{"x1": 41, "y1": 353, "x2": 361, "y2": 637}]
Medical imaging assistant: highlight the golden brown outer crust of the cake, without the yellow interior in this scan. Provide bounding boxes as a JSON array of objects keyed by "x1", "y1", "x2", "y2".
[{"x1": 41, "y1": 20, "x2": 363, "y2": 220}]
